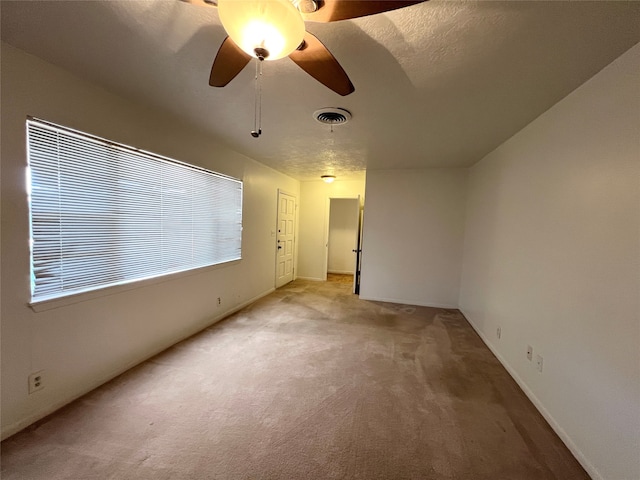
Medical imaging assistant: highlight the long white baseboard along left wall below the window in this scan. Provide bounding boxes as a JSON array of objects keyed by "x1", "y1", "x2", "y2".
[{"x1": 0, "y1": 288, "x2": 275, "y2": 440}]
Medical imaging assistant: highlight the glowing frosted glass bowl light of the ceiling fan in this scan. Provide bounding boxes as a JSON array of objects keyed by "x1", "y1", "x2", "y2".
[{"x1": 218, "y1": 0, "x2": 305, "y2": 60}]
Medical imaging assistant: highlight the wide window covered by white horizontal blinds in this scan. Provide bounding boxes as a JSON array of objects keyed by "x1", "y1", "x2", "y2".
[{"x1": 27, "y1": 119, "x2": 242, "y2": 303}]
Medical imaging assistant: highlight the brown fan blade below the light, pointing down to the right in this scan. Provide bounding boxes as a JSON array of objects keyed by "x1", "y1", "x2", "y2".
[{"x1": 289, "y1": 32, "x2": 355, "y2": 96}]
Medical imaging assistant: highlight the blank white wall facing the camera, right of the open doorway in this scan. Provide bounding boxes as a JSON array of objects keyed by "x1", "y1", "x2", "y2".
[{"x1": 360, "y1": 168, "x2": 467, "y2": 308}]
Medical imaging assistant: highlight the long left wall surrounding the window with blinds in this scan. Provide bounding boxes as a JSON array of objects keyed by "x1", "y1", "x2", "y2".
[{"x1": 1, "y1": 44, "x2": 299, "y2": 438}]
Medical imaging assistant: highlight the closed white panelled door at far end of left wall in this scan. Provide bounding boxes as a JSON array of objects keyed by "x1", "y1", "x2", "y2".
[{"x1": 276, "y1": 190, "x2": 296, "y2": 288}]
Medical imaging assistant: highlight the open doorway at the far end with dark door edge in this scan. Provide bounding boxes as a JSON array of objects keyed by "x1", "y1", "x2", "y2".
[{"x1": 325, "y1": 197, "x2": 361, "y2": 293}]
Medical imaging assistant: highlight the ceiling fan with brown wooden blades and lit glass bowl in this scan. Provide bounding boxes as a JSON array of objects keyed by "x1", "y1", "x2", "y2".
[{"x1": 182, "y1": 0, "x2": 426, "y2": 96}]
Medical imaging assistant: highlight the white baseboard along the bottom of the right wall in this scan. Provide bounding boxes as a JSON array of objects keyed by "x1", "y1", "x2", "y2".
[{"x1": 460, "y1": 308, "x2": 605, "y2": 480}]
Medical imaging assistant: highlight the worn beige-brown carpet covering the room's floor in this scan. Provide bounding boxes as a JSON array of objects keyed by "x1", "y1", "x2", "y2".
[{"x1": 1, "y1": 280, "x2": 588, "y2": 480}]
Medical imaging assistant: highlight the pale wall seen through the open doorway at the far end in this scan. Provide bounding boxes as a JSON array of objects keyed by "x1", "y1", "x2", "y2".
[{"x1": 327, "y1": 198, "x2": 360, "y2": 274}]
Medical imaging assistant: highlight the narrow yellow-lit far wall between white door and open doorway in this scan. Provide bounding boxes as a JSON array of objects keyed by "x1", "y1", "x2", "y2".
[{"x1": 296, "y1": 178, "x2": 365, "y2": 280}]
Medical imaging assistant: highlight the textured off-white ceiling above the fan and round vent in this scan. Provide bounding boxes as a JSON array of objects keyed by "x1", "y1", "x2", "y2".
[{"x1": 0, "y1": 0, "x2": 640, "y2": 180}]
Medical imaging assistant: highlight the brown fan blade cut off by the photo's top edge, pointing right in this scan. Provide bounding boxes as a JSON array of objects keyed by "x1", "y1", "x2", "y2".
[{"x1": 302, "y1": 0, "x2": 427, "y2": 22}]
